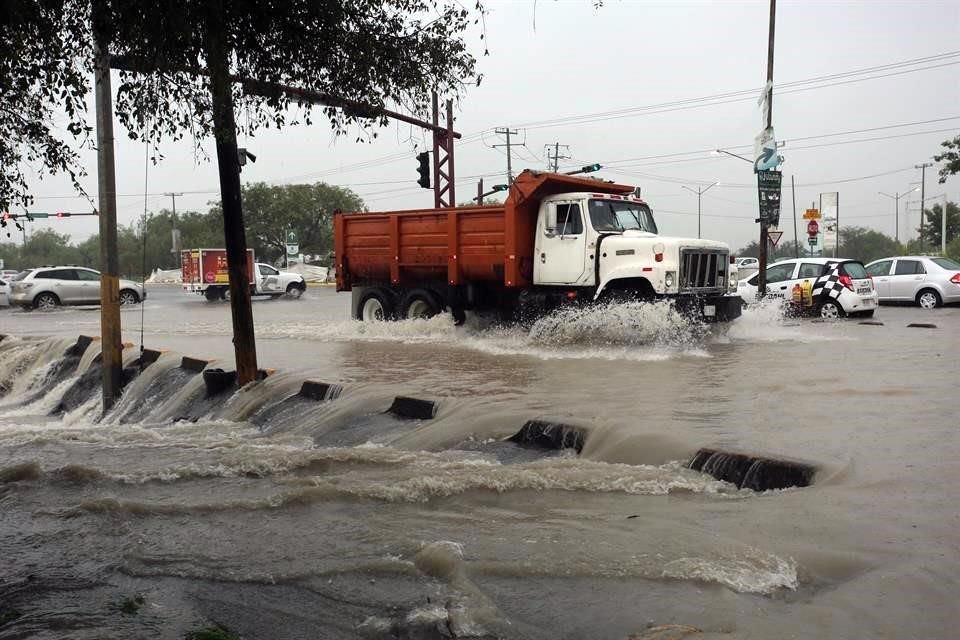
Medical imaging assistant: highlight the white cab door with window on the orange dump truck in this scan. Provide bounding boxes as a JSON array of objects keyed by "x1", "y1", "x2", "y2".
[{"x1": 533, "y1": 202, "x2": 587, "y2": 285}]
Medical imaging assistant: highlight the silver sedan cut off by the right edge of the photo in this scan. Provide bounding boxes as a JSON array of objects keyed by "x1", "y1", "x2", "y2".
[{"x1": 867, "y1": 256, "x2": 960, "y2": 309}]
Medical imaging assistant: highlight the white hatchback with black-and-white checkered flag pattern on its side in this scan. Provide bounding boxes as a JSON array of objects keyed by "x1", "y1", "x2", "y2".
[{"x1": 737, "y1": 258, "x2": 879, "y2": 318}]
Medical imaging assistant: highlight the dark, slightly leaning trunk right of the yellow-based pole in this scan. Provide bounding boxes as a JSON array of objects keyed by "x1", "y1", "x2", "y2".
[{"x1": 205, "y1": 0, "x2": 257, "y2": 386}]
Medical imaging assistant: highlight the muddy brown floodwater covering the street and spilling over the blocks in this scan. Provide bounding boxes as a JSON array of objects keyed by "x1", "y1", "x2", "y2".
[{"x1": 0, "y1": 287, "x2": 960, "y2": 640}]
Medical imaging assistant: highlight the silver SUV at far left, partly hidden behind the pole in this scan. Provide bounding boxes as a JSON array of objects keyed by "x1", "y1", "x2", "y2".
[{"x1": 10, "y1": 265, "x2": 147, "y2": 309}]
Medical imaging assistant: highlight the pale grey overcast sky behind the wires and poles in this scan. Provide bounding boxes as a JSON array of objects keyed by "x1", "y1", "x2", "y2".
[{"x1": 15, "y1": 0, "x2": 960, "y2": 254}]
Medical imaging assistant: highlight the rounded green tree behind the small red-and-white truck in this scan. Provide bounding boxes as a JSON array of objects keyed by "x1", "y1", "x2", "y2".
[{"x1": 206, "y1": 182, "x2": 366, "y2": 262}]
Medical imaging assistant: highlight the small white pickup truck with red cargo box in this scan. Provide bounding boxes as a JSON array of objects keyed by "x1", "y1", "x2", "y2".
[{"x1": 180, "y1": 249, "x2": 307, "y2": 302}]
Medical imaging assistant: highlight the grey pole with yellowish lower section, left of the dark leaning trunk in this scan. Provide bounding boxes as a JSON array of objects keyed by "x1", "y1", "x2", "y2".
[{"x1": 93, "y1": 0, "x2": 123, "y2": 413}]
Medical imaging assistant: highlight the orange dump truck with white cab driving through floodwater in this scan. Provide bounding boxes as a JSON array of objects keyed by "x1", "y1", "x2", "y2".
[{"x1": 334, "y1": 170, "x2": 741, "y2": 322}]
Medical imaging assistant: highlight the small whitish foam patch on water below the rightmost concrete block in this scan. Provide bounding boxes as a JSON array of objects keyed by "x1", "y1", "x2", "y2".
[{"x1": 662, "y1": 549, "x2": 798, "y2": 595}]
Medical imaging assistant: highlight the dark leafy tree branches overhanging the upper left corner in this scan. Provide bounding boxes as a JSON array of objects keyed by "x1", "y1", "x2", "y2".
[{"x1": 0, "y1": 0, "x2": 482, "y2": 226}]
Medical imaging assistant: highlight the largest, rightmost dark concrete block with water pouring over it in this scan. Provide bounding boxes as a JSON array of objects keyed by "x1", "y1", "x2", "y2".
[{"x1": 687, "y1": 449, "x2": 817, "y2": 491}]
